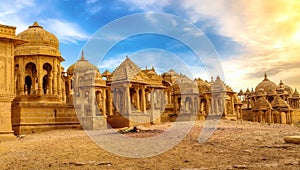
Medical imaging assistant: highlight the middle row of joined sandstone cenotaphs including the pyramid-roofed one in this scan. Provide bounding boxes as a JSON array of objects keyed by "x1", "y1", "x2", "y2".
[{"x1": 71, "y1": 53, "x2": 242, "y2": 129}]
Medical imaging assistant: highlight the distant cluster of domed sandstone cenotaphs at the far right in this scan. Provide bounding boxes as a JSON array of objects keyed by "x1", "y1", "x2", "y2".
[{"x1": 238, "y1": 74, "x2": 300, "y2": 124}]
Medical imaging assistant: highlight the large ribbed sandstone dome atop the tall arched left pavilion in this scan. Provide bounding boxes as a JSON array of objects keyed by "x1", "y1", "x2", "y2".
[{"x1": 15, "y1": 22, "x2": 60, "y2": 56}]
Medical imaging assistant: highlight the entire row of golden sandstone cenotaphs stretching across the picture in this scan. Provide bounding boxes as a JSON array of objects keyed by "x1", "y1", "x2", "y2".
[{"x1": 0, "y1": 22, "x2": 300, "y2": 138}]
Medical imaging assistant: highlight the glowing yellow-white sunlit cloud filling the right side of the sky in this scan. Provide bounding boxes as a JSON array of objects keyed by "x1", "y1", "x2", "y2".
[{"x1": 120, "y1": 0, "x2": 300, "y2": 89}]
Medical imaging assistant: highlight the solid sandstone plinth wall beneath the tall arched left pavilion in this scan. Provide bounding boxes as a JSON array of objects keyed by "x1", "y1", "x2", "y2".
[{"x1": 12, "y1": 103, "x2": 80, "y2": 135}]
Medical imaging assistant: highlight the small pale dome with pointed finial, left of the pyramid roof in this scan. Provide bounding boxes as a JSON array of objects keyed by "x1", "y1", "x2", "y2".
[{"x1": 67, "y1": 51, "x2": 100, "y2": 75}]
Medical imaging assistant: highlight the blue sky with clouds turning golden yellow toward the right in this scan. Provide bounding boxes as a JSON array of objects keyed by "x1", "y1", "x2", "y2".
[{"x1": 0, "y1": 0, "x2": 300, "y2": 91}]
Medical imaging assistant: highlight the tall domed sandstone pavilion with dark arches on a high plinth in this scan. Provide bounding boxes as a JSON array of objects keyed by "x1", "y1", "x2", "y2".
[{"x1": 10, "y1": 22, "x2": 79, "y2": 134}]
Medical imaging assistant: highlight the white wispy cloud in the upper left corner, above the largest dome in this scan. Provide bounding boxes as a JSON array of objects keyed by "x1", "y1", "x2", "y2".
[{"x1": 0, "y1": 0, "x2": 89, "y2": 44}]
